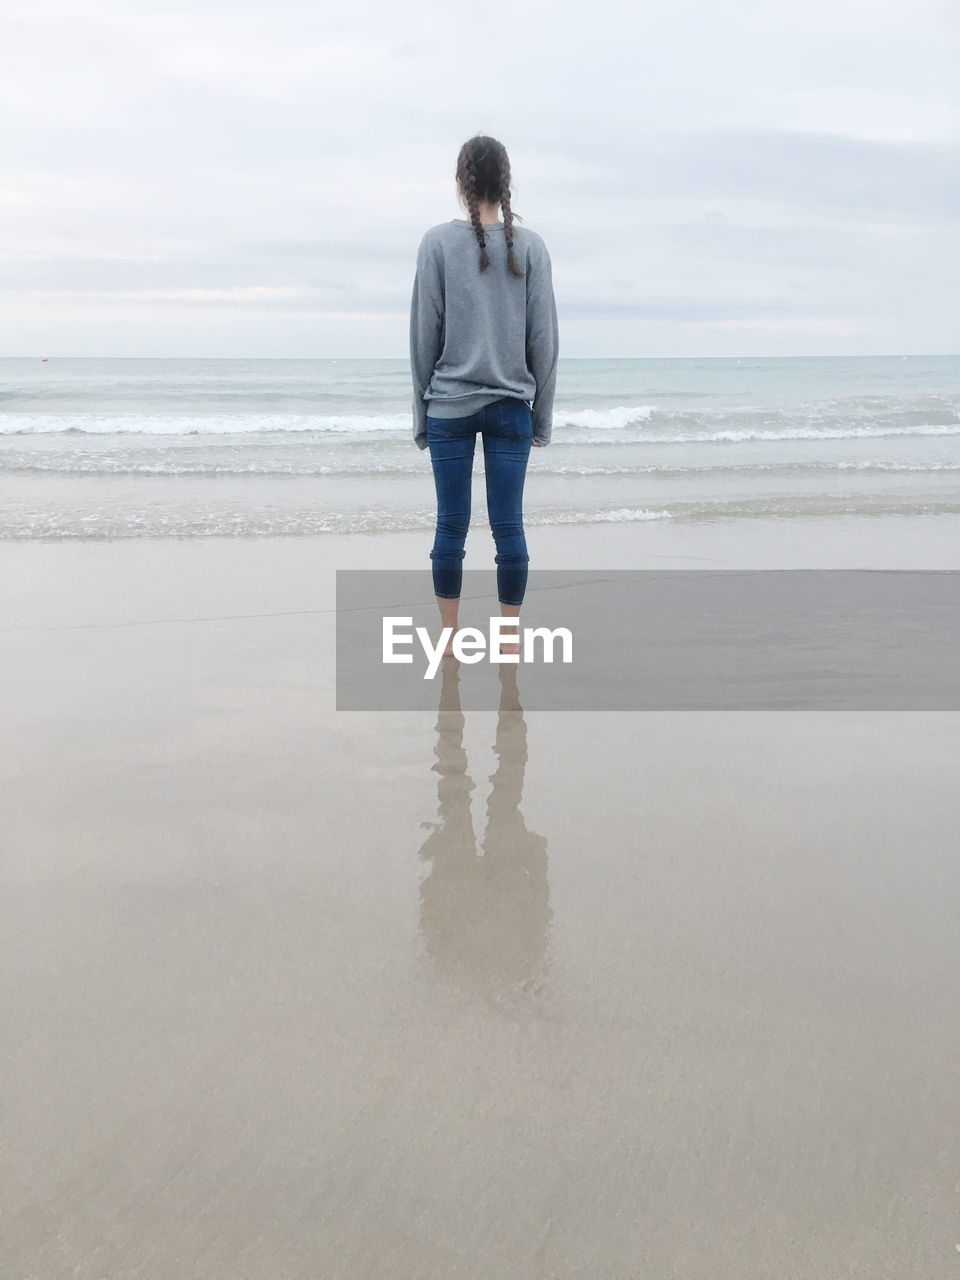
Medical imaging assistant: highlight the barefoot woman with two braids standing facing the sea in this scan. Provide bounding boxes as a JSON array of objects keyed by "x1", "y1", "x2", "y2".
[{"x1": 410, "y1": 134, "x2": 559, "y2": 653}]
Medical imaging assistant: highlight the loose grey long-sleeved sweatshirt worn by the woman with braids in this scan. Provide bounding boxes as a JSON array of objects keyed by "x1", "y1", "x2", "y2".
[{"x1": 410, "y1": 218, "x2": 559, "y2": 449}]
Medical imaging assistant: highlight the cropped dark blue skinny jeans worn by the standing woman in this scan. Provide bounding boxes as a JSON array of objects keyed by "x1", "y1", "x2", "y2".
[{"x1": 426, "y1": 397, "x2": 534, "y2": 605}]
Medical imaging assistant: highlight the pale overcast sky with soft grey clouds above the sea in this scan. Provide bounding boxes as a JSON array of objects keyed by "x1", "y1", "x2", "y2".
[{"x1": 0, "y1": 0, "x2": 960, "y2": 357}]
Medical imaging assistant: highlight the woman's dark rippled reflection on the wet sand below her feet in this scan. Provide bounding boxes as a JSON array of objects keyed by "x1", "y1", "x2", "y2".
[{"x1": 420, "y1": 658, "x2": 550, "y2": 986}]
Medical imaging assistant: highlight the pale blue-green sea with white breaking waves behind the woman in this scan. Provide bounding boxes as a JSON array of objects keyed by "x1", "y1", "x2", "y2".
[{"x1": 0, "y1": 355, "x2": 960, "y2": 540}]
